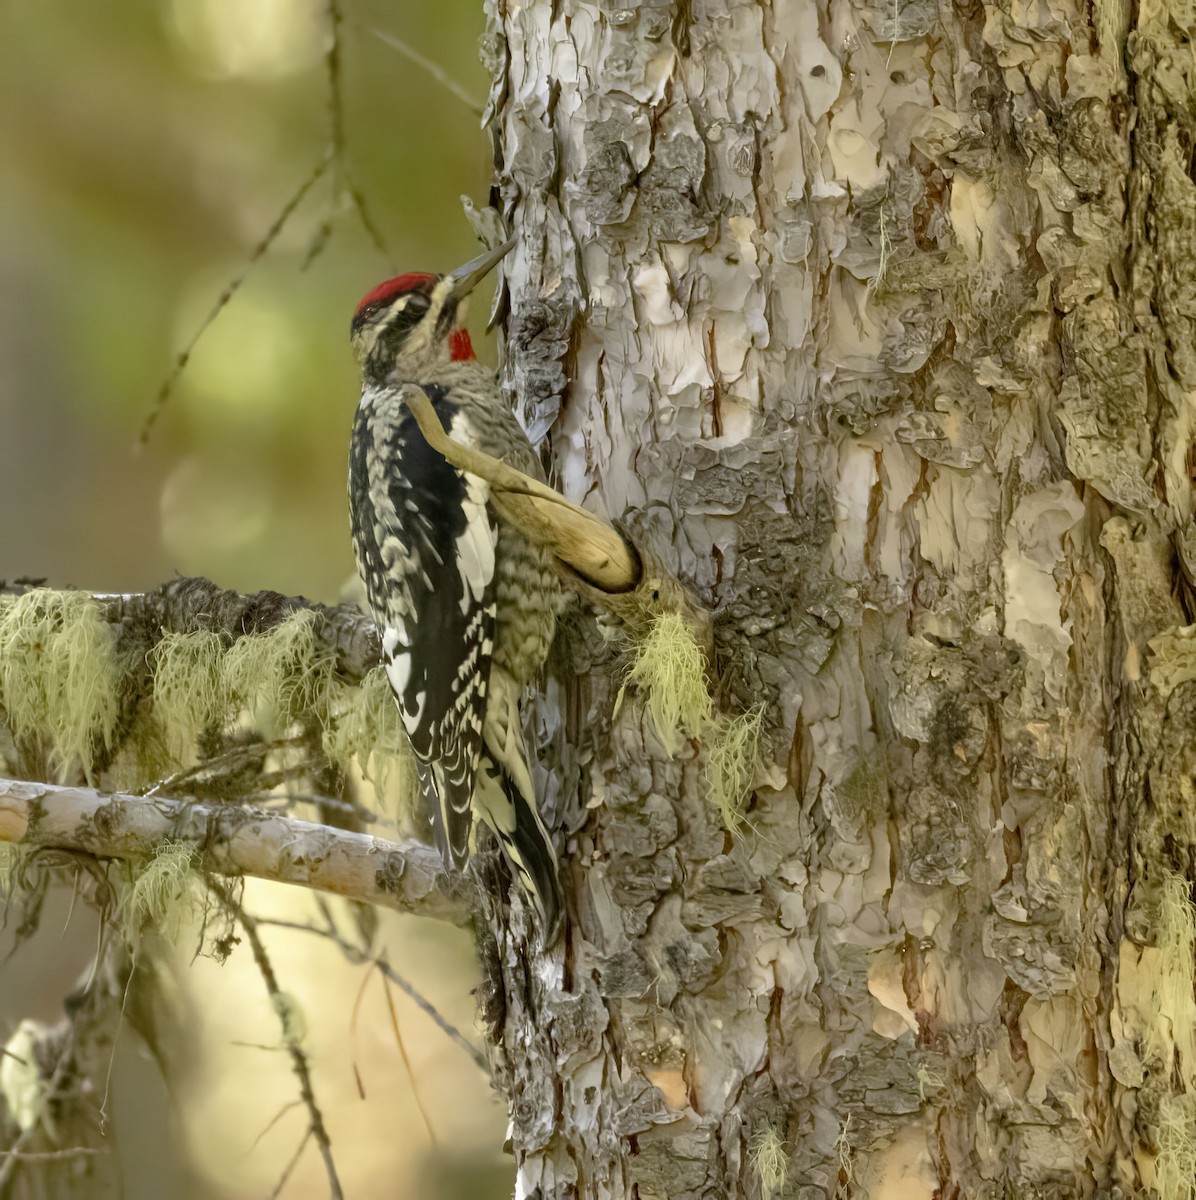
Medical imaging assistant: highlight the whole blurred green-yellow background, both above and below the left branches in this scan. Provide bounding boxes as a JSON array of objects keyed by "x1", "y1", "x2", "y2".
[{"x1": 0, "y1": 0, "x2": 510, "y2": 1200}]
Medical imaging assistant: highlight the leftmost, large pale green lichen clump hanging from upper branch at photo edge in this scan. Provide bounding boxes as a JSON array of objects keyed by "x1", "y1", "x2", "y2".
[{"x1": 0, "y1": 588, "x2": 124, "y2": 782}]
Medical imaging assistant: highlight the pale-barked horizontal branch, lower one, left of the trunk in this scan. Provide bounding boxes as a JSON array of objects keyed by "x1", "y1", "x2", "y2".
[{"x1": 0, "y1": 779, "x2": 469, "y2": 924}]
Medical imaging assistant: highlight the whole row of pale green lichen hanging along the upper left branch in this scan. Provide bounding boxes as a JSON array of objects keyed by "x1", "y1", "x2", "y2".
[{"x1": 0, "y1": 589, "x2": 407, "y2": 798}]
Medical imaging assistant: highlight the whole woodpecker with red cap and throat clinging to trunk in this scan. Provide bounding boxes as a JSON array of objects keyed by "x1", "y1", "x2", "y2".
[{"x1": 349, "y1": 242, "x2": 564, "y2": 944}]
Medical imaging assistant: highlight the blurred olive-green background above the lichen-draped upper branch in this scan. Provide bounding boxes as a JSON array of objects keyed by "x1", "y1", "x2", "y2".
[{"x1": 0, "y1": 0, "x2": 499, "y2": 599}]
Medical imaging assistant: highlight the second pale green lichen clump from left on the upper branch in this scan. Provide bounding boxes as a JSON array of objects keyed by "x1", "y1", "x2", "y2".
[{"x1": 148, "y1": 630, "x2": 234, "y2": 762}]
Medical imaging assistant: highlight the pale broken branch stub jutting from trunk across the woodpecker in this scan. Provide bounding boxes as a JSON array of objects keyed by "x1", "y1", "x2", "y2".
[{"x1": 403, "y1": 385, "x2": 711, "y2": 661}]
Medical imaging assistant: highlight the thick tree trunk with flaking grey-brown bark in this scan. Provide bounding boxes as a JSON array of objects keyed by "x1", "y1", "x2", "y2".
[{"x1": 483, "y1": 0, "x2": 1196, "y2": 1200}]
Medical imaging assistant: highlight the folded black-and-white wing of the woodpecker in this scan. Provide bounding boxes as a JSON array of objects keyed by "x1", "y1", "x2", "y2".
[{"x1": 349, "y1": 384, "x2": 498, "y2": 866}]
